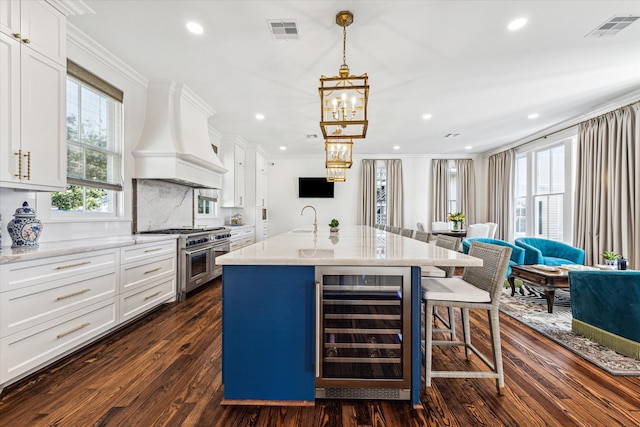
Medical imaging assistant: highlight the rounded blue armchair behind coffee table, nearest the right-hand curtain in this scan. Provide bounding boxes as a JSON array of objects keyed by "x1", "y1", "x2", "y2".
[{"x1": 515, "y1": 237, "x2": 584, "y2": 265}]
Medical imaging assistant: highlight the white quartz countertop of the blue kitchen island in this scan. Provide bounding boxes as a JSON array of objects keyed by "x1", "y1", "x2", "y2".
[{"x1": 216, "y1": 225, "x2": 482, "y2": 267}]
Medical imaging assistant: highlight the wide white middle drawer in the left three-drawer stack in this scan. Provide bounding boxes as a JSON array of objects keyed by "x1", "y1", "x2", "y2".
[{"x1": 0, "y1": 268, "x2": 118, "y2": 337}]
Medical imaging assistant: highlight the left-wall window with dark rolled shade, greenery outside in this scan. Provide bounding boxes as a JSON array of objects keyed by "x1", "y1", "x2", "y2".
[{"x1": 51, "y1": 62, "x2": 123, "y2": 215}]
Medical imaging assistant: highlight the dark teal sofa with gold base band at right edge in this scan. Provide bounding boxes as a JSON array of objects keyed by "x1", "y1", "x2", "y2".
[{"x1": 569, "y1": 270, "x2": 640, "y2": 360}]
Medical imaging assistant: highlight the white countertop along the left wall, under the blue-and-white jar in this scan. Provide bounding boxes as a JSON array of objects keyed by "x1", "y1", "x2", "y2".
[{"x1": 0, "y1": 234, "x2": 179, "y2": 264}]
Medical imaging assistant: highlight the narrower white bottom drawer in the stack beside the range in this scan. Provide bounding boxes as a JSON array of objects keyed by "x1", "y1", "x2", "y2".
[{"x1": 120, "y1": 275, "x2": 176, "y2": 322}]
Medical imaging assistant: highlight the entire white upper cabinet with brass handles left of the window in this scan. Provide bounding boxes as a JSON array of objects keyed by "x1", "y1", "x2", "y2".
[{"x1": 0, "y1": 0, "x2": 67, "y2": 191}]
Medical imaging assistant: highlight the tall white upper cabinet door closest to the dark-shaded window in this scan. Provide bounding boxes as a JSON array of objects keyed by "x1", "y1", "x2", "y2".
[{"x1": 20, "y1": 45, "x2": 67, "y2": 191}]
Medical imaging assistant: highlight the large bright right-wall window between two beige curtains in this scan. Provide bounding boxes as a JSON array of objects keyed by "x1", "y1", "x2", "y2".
[{"x1": 514, "y1": 136, "x2": 576, "y2": 242}]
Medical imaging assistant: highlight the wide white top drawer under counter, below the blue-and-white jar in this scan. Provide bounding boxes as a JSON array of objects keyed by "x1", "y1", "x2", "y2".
[{"x1": 0, "y1": 249, "x2": 118, "y2": 292}]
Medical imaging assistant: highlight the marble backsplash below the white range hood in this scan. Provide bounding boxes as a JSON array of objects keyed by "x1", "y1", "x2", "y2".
[{"x1": 133, "y1": 179, "x2": 193, "y2": 232}]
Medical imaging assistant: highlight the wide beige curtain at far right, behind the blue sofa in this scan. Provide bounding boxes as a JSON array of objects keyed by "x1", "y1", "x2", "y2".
[{"x1": 573, "y1": 102, "x2": 640, "y2": 269}]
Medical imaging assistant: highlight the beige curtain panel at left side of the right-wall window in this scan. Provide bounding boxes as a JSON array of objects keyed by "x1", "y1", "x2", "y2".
[{"x1": 487, "y1": 149, "x2": 515, "y2": 241}]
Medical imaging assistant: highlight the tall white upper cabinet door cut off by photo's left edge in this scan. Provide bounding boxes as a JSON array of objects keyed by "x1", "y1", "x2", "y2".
[{"x1": 0, "y1": 32, "x2": 20, "y2": 183}]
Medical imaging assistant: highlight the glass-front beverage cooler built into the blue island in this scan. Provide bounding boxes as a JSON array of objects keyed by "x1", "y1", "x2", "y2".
[{"x1": 315, "y1": 266, "x2": 411, "y2": 400}]
